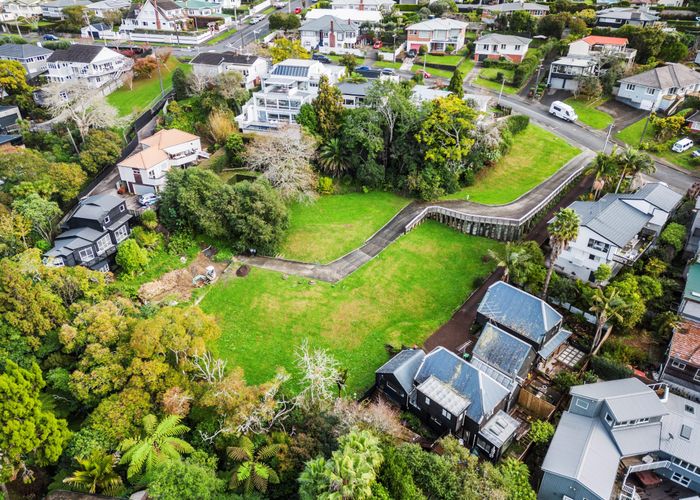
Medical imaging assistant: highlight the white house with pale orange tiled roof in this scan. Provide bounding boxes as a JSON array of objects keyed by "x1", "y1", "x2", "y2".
[{"x1": 117, "y1": 129, "x2": 206, "y2": 194}]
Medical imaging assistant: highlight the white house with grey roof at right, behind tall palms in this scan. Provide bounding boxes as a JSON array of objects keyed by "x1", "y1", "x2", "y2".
[{"x1": 554, "y1": 183, "x2": 682, "y2": 281}]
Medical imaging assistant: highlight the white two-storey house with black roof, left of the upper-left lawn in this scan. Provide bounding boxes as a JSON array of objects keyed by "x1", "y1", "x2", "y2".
[{"x1": 47, "y1": 43, "x2": 133, "y2": 91}]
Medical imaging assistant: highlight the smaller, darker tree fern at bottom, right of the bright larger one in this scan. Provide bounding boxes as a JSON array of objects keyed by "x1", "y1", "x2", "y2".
[{"x1": 227, "y1": 436, "x2": 280, "y2": 495}]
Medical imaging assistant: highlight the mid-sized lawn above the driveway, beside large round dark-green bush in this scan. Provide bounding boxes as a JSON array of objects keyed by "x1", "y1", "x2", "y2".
[{"x1": 280, "y1": 191, "x2": 410, "y2": 263}]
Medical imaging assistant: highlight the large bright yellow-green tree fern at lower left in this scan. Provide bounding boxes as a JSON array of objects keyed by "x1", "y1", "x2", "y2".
[{"x1": 119, "y1": 415, "x2": 194, "y2": 479}]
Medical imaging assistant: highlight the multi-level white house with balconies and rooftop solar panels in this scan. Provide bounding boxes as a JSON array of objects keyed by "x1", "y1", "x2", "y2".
[{"x1": 236, "y1": 59, "x2": 345, "y2": 131}]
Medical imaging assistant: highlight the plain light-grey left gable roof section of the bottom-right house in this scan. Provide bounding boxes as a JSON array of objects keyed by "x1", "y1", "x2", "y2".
[{"x1": 542, "y1": 411, "x2": 620, "y2": 498}]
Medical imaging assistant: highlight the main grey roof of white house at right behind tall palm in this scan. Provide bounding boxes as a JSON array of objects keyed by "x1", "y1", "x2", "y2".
[{"x1": 569, "y1": 195, "x2": 652, "y2": 247}]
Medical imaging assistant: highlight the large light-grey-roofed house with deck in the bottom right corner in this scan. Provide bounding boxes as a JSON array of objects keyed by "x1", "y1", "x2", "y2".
[{"x1": 537, "y1": 378, "x2": 700, "y2": 500}]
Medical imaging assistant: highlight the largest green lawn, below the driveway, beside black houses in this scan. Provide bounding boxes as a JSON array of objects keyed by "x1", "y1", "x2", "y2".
[{"x1": 200, "y1": 221, "x2": 501, "y2": 394}]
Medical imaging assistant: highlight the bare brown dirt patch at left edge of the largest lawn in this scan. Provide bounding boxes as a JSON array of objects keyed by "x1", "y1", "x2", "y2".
[{"x1": 139, "y1": 252, "x2": 228, "y2": 302}]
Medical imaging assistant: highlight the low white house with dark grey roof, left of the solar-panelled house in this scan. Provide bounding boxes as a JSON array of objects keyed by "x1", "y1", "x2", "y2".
[{"x1": 190, "y1": 52, "x2": 268, "y2": 89}]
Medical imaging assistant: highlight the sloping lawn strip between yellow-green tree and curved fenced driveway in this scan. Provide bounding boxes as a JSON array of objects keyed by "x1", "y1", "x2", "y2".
[{"x1": 445, "y1": 125, "x2": 580, "y2": 205}]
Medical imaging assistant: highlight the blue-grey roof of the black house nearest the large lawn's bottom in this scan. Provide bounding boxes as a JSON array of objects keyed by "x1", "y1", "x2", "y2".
[{"x1": 415, "y1": 347, "x2": 508, "y2": 423}]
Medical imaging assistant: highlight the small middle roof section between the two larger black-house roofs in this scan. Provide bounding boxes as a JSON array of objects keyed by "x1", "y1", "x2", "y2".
[{"x1": 472, "y1": 323, "x2": 535, "y2": 376}]
